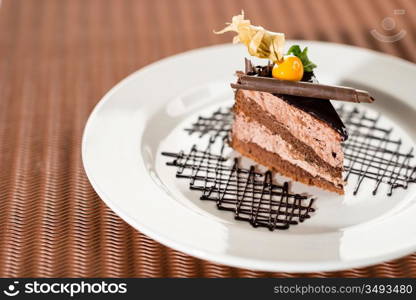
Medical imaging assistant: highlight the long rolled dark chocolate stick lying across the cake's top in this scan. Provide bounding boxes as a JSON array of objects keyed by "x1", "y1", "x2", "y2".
[{"x1": 231, "y1": 73, "x2": 374, "y2": 103}]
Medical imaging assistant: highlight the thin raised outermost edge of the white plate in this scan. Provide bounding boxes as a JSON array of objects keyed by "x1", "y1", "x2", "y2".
[{"x1": 81, "y1": 40, "x2": 416, "y2": 273}]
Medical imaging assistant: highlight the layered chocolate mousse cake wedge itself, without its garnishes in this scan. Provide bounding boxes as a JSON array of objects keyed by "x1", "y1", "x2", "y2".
[{"x1": 231, "y1": 64, "x2": 347, "y2": 194}]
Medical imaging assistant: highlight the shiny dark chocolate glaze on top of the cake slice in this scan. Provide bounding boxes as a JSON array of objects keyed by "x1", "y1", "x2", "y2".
[{"x1": 246, "y1": 59, "x2": 348, "y2": 141}]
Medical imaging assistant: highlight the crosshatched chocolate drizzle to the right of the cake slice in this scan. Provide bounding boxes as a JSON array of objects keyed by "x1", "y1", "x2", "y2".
[{"x1": 337, "y1": 106, "x2": 416, "y2": 196}]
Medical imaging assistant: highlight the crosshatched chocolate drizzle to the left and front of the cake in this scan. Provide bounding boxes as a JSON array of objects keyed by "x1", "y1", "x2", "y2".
[{"x1": 162, "y1": 137, "x2": 315, "y2": 231}]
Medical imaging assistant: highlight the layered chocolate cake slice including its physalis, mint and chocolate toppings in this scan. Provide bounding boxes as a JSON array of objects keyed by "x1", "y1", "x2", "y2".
[{"x1": 214, "y1": 11, "x2": 374, "y2": 194}]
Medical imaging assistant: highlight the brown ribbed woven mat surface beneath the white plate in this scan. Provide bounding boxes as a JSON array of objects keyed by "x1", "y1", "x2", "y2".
[{"x1": 0, "y1": 0, "x2": 416, "y2": 277}]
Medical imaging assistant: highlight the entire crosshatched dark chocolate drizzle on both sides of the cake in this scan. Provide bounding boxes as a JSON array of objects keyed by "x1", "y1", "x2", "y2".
[{"x1": 162, "y1": 106, "x2": 416, "y2": 230}]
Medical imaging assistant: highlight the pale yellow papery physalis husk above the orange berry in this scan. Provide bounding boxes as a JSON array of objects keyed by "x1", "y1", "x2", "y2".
[{"x1": 214, "y1": 11, "x2": 285, "y2": 62}]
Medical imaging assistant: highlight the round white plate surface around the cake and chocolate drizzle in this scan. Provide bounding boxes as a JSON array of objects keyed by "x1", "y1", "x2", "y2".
[{"x1": 82, "y1": 41, "x2": 416, "y2": 272}]
